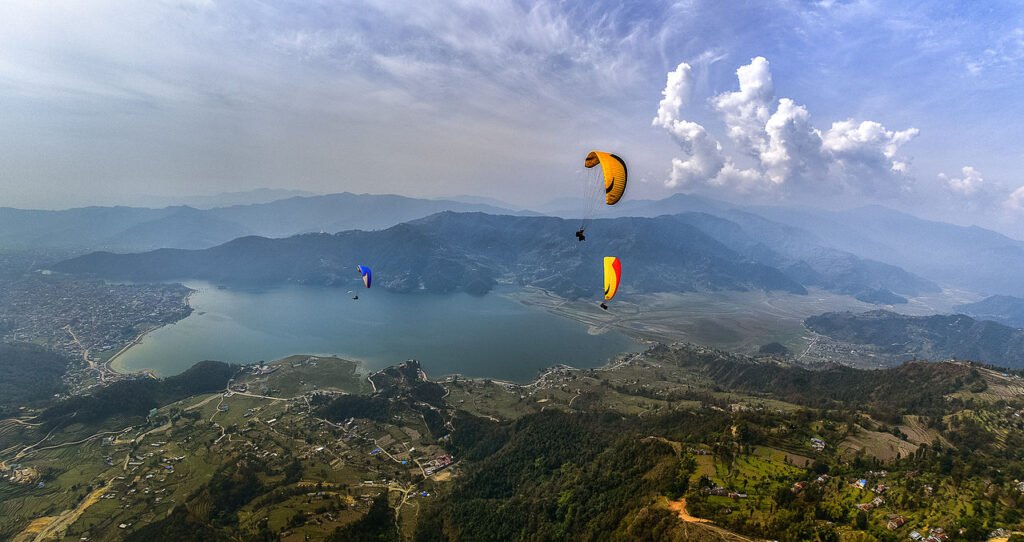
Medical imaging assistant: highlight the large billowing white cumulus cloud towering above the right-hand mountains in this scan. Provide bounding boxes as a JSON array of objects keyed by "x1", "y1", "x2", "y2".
[{"x1": 652, "y1": 56, "x2": 919, "y2": 198}]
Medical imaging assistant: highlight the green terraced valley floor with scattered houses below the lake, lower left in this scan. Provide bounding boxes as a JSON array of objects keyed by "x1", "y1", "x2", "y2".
[{"x1": 0, "y1": 357, "x2": 457, "y2": 540}]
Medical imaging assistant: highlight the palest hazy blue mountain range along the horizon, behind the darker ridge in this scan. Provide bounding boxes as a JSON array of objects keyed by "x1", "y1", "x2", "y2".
[{"x1": 6, "y1": 191, "x2": 1024, "y2": 304}]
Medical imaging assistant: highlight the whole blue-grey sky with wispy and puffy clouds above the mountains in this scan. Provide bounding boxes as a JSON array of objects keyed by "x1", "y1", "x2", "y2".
[{"x1": 0, "y1": 0, "x2": 1024, "y2": 237}]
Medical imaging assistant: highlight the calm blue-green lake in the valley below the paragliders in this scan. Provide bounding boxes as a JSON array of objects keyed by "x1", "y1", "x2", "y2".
[{"x1": 115, "y1": 282, "x2": 641, "y2": 381}]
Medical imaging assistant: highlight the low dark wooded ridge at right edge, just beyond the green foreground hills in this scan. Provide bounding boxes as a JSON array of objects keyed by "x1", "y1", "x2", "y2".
[{"x1": 804, "y1": 310, "x2": 1024, "y2": 369}]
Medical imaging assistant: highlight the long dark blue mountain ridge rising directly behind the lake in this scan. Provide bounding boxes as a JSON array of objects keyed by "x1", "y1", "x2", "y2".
[{"x1": 54, "y1": 212, "x2": 935, "y2": 298}]
